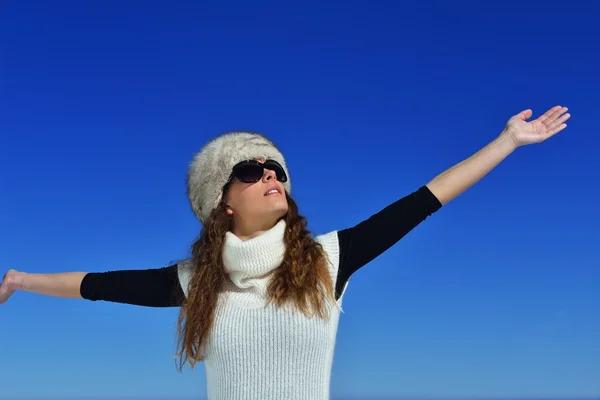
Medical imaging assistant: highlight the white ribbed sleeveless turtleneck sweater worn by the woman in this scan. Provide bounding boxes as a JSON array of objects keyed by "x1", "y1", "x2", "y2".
[{"x1": 179, "y1": 220, "x2": 347, "y2": 400}]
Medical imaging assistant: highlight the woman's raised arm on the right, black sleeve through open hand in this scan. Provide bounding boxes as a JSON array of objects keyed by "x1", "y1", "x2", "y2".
[{"x1": 336, "y1": 106, "x2": 570, "y2": 293}]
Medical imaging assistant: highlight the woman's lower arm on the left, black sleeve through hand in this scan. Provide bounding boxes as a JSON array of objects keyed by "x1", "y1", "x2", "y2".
[{"x1": 0, "y1": 264, "x2": 185, "y2": 307}]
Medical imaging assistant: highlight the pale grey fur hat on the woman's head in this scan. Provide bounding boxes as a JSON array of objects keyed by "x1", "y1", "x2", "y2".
[{"x1": 187, "y1": 132, "x2": 291, "y2": 223}]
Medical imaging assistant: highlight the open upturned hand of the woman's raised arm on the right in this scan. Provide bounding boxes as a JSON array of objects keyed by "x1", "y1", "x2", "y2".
[{"x1": 502, "y1": 106, "x2": 571, "y2": 147}]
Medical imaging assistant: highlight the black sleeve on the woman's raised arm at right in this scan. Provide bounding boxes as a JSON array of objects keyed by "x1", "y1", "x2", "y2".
[{"x1": 336, "y1": 185, "x2": 442, "y2": 296}]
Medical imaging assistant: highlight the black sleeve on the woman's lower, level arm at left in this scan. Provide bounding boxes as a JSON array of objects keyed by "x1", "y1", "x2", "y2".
[{"x1": 80, "y1": 264, "x2": 185, "y2": 307}]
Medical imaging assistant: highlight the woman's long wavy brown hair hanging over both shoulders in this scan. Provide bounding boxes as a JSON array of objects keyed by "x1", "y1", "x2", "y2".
[{"x1": 177, "y1": 193, "x2": 335, "y2": 371}]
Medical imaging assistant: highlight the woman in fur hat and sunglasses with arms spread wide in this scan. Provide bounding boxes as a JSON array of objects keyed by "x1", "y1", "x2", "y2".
[{"x1": 0, "y1": 106, "x2": 570, "y2": 400}]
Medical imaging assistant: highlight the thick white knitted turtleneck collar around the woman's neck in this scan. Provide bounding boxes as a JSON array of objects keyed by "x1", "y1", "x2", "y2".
[{"x1": 223, "y1": 219, "x2": 286, "y2": 294}]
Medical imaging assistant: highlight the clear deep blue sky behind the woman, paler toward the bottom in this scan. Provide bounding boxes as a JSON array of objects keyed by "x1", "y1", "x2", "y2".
[{"x1": 0, "y1": 1, "x2": 600, "y2": 398}]
